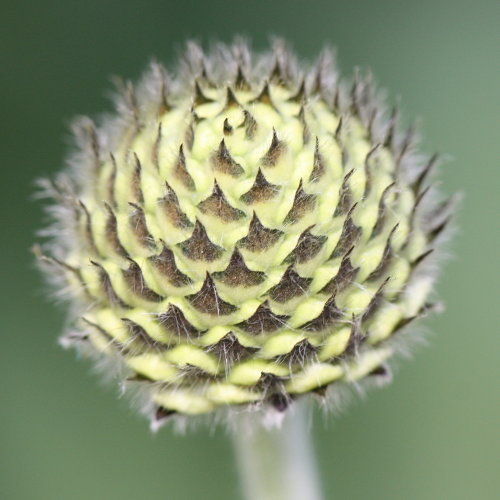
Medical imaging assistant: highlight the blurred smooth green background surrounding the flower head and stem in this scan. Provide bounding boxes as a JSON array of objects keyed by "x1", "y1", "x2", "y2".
[{"x1": 0, "y1": 0, "x2": 500, "y2": 500}]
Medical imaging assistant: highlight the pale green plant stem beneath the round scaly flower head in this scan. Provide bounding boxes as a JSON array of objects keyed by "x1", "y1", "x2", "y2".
[{"x1": 233, "y1": 403, "x2": 322, "y2": 500}]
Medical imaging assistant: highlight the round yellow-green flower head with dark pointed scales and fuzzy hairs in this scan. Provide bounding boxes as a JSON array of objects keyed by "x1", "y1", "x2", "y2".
[{"x1": 40, "y1": 41, "x2": 449, "y2": 428}]
